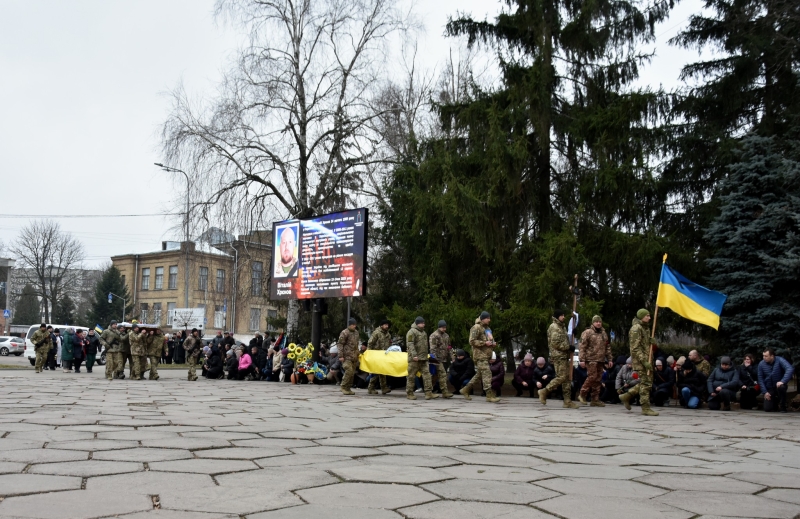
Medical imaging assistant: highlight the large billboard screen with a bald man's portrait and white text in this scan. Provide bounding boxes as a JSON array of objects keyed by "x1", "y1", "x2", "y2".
[{"x1": 269, "y1": 208, "x2": 367, "y2": 300}]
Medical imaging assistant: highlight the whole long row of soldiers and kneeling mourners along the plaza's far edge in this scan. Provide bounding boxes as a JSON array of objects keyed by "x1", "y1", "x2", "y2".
[{"x1": 25, "y1": 309, "x2": 794, "y2": 415}]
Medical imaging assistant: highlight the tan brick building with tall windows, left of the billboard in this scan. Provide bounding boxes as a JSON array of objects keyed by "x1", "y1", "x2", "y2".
[{"x1": 111, "y1": 229, "x2": 278, "y2": 335}]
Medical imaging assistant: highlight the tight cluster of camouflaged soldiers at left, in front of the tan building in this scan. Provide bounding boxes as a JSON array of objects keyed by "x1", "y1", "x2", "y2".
[{"x1": 100, "y1": 321, "x2": 167, "y2": 380}]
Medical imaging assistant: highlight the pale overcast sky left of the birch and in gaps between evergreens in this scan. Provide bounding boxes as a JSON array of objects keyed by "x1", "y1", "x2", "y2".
[{"x1": 0, "y1": 0, "x2": 699, "y2": 266}]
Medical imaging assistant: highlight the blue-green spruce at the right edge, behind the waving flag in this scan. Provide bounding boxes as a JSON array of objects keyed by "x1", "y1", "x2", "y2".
[{"x1": 706, "y1": 135, "x2": 800, "y2": 361}]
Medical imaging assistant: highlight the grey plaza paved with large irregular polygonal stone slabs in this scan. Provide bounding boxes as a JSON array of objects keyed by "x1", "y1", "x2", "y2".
[{"x1": 0, "y1": 370, "x2": 800, "y2": 519}]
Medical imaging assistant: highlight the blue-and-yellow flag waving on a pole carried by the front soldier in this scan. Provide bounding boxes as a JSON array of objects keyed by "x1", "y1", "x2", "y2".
[{"x1": 656, "y1": 254, "x2": 728, "y2": 330}]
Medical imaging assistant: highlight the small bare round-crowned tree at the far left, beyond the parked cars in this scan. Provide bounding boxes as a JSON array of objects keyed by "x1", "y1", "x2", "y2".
[{"x1": 10, "y1": 220, "x2": 84, "y2": 322}]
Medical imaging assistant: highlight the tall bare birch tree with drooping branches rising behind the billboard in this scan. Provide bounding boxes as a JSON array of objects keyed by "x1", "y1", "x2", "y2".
[{"x1": 162, "y1": 0, "x2": 416, "y2": 230}]
